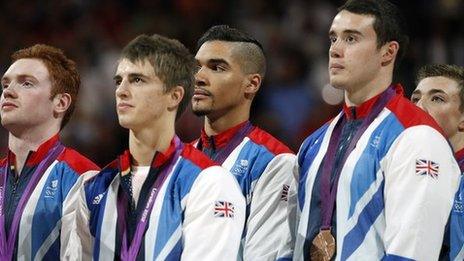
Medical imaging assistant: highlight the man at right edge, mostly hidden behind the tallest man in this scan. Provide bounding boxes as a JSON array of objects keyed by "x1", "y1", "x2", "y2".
[{"x1": 411, "y1": 64, "x2": 464, "y2": 260}]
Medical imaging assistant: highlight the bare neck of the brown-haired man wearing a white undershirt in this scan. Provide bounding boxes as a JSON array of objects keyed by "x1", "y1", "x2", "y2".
[{"x1": 129, "y1": 124, "x2": 175, "y2": 166}]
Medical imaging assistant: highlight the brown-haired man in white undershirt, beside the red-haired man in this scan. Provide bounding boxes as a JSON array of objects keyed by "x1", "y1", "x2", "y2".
[{"x1": 78, "y1": 35, "x2": 245, "y2": 260}]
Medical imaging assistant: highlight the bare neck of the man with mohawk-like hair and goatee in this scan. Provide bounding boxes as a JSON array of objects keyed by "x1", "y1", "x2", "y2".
[{"x1": 205, "y1": 103, "x2": 250, "y2": 136}]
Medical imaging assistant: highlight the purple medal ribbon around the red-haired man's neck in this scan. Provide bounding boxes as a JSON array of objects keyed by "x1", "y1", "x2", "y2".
[{"x1": 0, "y1": 141, "x2": 64, "y2": 260}]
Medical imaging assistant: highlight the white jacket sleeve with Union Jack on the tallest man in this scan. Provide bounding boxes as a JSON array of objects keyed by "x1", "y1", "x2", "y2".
[{"x1": 381, "y1": 125, "x2": 460, "y2": 260}]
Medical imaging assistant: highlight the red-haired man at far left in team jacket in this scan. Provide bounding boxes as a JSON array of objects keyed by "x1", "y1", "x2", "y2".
[{"x1": 0, "y1": 44, "x2": 99, "y2": 260}]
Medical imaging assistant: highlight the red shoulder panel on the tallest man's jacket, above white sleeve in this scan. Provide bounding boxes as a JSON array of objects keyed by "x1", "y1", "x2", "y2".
[{"x1": 387, "y1": 95, "x2": 443, "y2": 135}]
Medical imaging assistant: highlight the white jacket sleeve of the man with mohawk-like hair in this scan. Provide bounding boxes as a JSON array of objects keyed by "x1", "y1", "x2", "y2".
[{"x1": 243, "y1": 153, "x2": 296, "y2": 260}]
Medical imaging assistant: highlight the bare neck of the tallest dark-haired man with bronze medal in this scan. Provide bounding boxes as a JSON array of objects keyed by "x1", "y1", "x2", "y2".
[{"x1": 345, "y1": 71, "x2": 392, "y2": 107}]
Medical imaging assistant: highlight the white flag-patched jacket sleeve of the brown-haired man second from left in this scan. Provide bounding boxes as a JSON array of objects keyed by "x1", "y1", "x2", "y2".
[{"x1": 181, "y1": 166, "x2": 246, "y2": 260}]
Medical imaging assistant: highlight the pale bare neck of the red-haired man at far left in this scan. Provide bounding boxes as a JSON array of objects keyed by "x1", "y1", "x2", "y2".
[{"x1": 8, "y1": 127, "x2": 59, "y2": 175}]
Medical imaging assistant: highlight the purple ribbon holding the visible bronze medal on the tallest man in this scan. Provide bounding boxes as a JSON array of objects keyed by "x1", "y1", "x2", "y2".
[{"x1": 320, "y1": 86, "x2": 396, "y2": 230}]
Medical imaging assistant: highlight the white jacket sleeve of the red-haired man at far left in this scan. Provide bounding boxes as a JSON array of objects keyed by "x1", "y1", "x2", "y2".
[{"x1": 60, "y1": 171, "x2": 98, "y2": 260}]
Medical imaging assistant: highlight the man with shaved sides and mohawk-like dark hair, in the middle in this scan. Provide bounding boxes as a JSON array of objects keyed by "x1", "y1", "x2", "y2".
[{"x1": 192, "y1": 25, "x2": 295, "y2": 260}]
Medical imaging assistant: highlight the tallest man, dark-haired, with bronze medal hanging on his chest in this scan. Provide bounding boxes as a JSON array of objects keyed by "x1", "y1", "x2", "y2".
[{"x1": 294, "y1": 0, "x2": 459, "y2": 260}]
